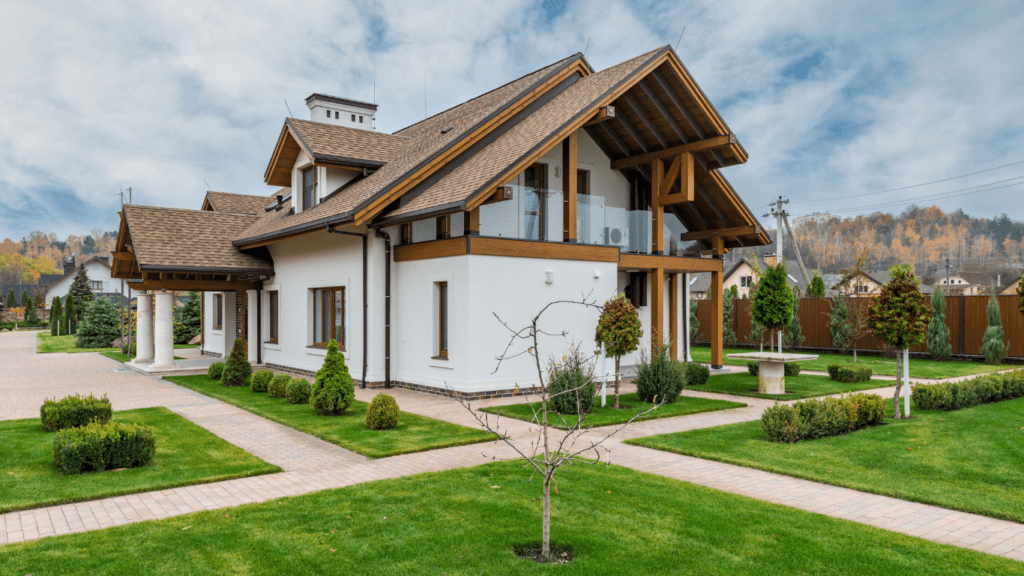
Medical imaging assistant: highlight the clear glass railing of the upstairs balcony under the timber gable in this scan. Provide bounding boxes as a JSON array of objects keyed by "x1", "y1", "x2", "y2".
[{"x1": 480, "y1": 186, "x2": 686, "y2": 254}]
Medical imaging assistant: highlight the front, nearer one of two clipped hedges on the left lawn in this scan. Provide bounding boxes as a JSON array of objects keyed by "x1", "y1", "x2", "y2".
[{"x1": 53, "y1": 422, "x2": 157, "y2": 475}]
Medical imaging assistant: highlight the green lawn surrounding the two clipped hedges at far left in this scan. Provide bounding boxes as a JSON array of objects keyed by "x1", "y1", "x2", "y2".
[{"x1": 0, "y1": 408, "x2": 281, "y2": 512}]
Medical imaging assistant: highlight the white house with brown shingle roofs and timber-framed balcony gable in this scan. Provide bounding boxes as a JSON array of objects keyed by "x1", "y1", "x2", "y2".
[{"x1": 113, "y1": 46, "x2": 768, "y2": 398}]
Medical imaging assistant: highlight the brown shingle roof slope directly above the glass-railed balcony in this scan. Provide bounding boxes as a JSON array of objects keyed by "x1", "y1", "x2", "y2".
[{"x1": 385, "y1": 48, "x2": 664, "y2": 218}]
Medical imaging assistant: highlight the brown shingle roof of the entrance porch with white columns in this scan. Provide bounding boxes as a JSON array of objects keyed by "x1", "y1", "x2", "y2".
[{"x1": 124, "y1": 203, "x2": 273, "y2": 275}]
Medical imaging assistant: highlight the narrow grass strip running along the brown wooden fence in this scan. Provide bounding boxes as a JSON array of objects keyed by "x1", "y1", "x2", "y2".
[{"x1": 692, "y1": 346, "x2": 1007, "y2": 379}]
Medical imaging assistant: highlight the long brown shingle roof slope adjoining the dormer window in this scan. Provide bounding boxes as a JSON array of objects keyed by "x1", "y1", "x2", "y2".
[{"x1": 236, "y1": 50, "x2": 581, "y2": 245}]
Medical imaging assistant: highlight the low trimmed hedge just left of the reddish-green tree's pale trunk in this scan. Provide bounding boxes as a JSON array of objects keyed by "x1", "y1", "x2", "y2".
[{"x1": 761, "y1": 394, "x2": 886, "y2": 443}]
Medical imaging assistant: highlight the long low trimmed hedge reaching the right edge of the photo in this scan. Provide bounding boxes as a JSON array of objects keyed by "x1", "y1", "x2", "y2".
[{"x1": 911, "y1": 370, "x2": 1024, "y2": 411}]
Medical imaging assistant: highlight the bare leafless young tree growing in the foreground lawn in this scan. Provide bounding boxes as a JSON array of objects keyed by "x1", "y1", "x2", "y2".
[{"x1": 445, "y1": 296, "x2": 664, "y2": 562}]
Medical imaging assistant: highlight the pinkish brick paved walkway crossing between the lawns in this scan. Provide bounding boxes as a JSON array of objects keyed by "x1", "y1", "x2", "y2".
[{"x1": 0, "y1": 334, "x2": 1024, "y2": 561}]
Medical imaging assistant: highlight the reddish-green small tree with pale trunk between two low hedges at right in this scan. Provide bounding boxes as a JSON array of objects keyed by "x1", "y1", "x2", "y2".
[{"x1": 867, "y1": 264, "x2": 932, "y2": 419}]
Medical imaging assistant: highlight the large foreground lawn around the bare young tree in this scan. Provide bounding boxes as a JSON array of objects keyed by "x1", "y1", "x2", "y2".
[{"x1": 0, "y1": 462, "x2": 1022, "y2": 576}]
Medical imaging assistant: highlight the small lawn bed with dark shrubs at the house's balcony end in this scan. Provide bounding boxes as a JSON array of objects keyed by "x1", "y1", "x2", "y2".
[{"x1": 480, "y1": 394, "x2": 746, "y2": 429}]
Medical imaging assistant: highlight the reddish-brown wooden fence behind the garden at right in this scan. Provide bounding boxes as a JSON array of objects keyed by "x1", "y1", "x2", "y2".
[{"x1": 694, "y1": 296, "x2": 1024, "y2": 358}]
